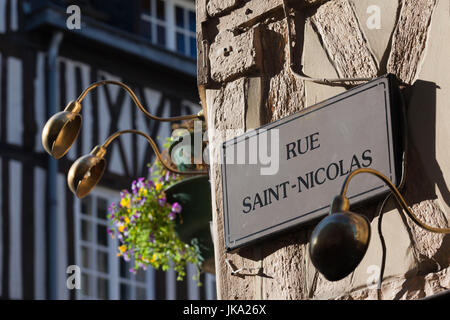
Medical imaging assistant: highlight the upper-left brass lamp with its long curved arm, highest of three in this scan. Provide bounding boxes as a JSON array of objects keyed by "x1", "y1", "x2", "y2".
[{"x1": 42, "y1": 80, "x2": 203, "y2": 159}]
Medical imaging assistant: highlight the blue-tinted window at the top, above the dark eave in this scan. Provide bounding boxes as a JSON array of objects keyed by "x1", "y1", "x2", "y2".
[{"x1": 141, "y1": 0, "x2": 197, "y2": 59}]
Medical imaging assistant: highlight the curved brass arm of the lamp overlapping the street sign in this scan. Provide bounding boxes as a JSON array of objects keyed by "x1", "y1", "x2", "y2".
[{"x1": 341, "y1": 168, "x2": 450, "y2": 233}]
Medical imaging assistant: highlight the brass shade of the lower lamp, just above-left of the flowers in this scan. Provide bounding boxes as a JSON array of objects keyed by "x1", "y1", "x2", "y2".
[{"x1": 67, "y1": 146, "x2": 106, "y2": 199}]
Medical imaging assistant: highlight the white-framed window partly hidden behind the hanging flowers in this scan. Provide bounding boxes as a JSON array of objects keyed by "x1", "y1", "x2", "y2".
[{"x1": 76, "y1": 188, "x2": 154, "y2": 299}]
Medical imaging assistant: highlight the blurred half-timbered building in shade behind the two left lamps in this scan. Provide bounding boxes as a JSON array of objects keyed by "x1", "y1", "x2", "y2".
[{"x1": 0, "y1": 0, "x2": 215, "y2": 299}]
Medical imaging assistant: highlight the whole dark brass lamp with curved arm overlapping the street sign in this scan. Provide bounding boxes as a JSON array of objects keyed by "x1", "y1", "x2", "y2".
[{"x1": 309, "y1": 168, "x2": 450, "y2": 281}]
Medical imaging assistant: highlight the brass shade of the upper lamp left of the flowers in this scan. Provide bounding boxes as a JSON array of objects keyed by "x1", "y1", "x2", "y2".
[{"x1": 42, "y1": 102, "x2": 82, "y2": 159}]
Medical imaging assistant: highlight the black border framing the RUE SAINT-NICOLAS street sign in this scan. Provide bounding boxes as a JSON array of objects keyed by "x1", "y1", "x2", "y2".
[{"x1": 221, "y1": 74, "x2": 399, "y2": 251}]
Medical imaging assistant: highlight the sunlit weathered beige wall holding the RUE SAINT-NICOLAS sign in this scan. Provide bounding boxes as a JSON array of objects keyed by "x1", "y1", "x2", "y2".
[{"x1": 197, "y1": 0, "x2": 450, "y2": 299}]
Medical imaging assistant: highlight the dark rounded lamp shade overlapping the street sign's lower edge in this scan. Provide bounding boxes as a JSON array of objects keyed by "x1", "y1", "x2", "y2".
[{"x1": 309, "y1": 211, "x2": 370, "y2": 281}]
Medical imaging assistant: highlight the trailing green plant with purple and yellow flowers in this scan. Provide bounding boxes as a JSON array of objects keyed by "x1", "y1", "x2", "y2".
[{"x1": 108, "y1": 138, "x2": 203, "y2": 285}]
